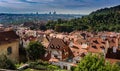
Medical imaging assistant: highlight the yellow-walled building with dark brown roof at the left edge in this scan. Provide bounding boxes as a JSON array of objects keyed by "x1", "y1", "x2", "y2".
[{"x1": 0, "y1": 31, "x2": 19, "y2": 62}]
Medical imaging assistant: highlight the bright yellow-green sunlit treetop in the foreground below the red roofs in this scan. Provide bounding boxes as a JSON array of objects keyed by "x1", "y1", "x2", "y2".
[{"x1": 75, "y1": 54, "x2": 120, "y2": 71}]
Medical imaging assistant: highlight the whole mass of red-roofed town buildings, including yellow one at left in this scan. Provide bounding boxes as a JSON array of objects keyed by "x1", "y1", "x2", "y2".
[{"x1": 0, "y1": 27, "x2": 120, "y2": 70}]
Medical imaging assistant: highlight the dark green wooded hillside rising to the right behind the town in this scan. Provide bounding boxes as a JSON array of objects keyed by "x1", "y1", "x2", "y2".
[{"x1": 46, "y1": 5, "x2": 120, "y2": 32}]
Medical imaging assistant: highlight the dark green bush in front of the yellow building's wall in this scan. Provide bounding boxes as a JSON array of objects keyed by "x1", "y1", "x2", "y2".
[{"x1": 0, "y1": 55, "x2": 16, "y2": 70}]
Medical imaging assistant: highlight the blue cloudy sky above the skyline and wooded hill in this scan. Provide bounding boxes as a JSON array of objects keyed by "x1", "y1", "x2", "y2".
[{"x1": 0, "y1": 0, "x2": 120, "y2": 14}]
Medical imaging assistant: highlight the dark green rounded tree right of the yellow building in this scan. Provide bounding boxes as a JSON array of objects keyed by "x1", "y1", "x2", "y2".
[{"x1": 26, "y1": 42, "x2": 46, "y2": 61}]
